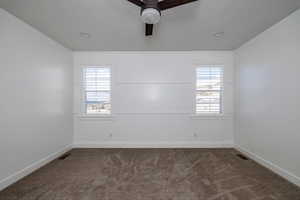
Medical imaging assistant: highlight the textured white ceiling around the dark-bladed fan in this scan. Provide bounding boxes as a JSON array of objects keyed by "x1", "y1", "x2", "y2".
[{"x1": 0, "y1": 0, "x2": 300, "y2": 51}]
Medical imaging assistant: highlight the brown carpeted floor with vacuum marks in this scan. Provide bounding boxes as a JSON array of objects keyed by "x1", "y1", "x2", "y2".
[{"x1": 0, "y1": 149, "x2": 300, "y2": 200}]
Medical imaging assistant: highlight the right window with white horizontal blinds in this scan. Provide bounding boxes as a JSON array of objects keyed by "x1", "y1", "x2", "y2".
[{"x1": 196, "y1": 66, "x2": 223, "y2": 114}]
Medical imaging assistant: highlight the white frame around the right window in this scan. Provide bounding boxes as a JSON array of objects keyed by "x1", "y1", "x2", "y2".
[{"x1": 192, "y1": 64, "x2": 225, "y2": 117}]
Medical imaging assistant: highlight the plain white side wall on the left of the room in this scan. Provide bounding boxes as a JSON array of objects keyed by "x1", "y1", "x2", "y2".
[{"x1": 0, "y1": 9, "x2": 73, "y2": 190}]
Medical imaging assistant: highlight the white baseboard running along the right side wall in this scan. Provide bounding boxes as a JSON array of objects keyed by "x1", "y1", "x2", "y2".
[{"x1": 235, "y1": 145, "x2": 300, "y2": 187}]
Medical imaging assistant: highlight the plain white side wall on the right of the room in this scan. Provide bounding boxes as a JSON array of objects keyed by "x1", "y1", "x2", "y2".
[{"x1": 235, "y1": 10, "x2": 300, "y2": 185}]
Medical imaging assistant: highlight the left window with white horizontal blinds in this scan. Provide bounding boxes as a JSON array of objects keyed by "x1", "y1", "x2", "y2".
[{"x1": 84, "y1": 67, "x2": 111, "y2": 114}]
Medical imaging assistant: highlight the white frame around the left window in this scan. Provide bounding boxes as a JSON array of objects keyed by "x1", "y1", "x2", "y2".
[{"x1": 80, "y1": 64, "x2": 113, "y2": 115}]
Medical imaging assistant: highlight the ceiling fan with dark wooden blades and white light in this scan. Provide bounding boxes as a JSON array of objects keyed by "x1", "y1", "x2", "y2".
[{"x1": 128, "y1": 0, "x2": 198, "y2": 36}]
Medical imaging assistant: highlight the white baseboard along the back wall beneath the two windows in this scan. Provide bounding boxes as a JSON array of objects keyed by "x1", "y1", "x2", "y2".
[{"x1": 73, "y1": 141, "x2": 234, "y2": 148}]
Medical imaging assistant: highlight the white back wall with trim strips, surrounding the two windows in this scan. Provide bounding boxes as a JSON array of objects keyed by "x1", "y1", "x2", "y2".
[{"x1": 74, "y1": 52, "x2": 234, "y2": 147}]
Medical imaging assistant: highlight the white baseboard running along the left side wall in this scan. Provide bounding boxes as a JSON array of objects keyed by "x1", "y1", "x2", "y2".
[{"x1": 0, "y1": 145, "x2": 72, "y2": 191}]
